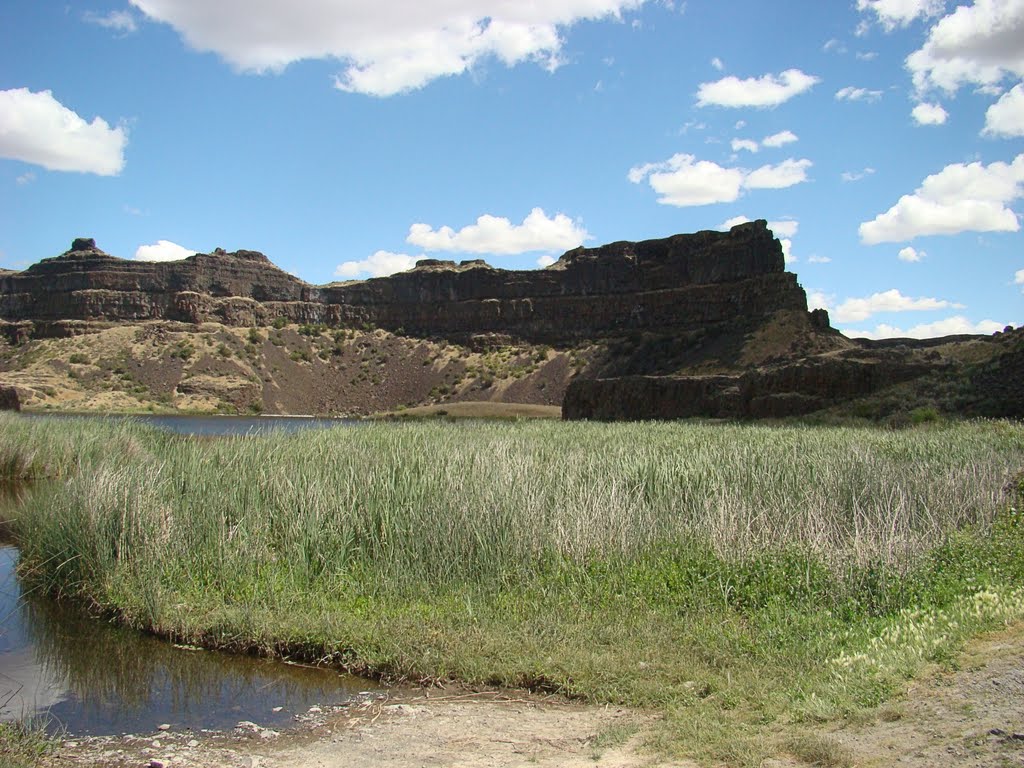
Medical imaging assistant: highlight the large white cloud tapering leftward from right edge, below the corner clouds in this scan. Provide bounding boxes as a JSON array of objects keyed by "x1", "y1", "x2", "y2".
[{"x1": 859, "y1": 155, "x2": 1024, "y2": 245}]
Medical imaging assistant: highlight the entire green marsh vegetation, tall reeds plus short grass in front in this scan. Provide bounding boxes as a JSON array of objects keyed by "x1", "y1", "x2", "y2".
[{"x1": 6, "y1": 415, "x2": 1024, "y2": 765}]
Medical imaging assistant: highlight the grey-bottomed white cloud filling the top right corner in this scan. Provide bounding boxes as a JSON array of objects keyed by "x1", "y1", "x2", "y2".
[{"x1": 906, "y1": 0, "x2": 1024, "y2": 93}]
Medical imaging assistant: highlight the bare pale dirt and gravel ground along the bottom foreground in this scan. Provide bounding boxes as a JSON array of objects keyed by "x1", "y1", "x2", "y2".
[{"x1": 48, "y1": 624, "x2": 1024, "y2": 768}]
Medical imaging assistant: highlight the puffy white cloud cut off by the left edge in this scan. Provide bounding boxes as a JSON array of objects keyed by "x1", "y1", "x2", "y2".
[{"x1": 0, "y1": 88, "x2": 128, "y2": 176}]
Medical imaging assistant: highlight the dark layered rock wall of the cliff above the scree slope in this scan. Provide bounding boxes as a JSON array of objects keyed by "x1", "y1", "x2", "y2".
[{"x1": 0, "y1": 220, "x2": 807, "y2": 343}]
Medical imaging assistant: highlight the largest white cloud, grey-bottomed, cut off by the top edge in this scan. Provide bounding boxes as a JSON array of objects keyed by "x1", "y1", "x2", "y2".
[{"x1": 130, "y1": 0, "x2": 644, "y2": 96}]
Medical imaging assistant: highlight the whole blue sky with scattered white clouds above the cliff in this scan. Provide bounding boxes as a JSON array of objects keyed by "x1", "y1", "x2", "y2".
[{"x1": 0, "y1": 0, "x2": 1024, "y2": 336}]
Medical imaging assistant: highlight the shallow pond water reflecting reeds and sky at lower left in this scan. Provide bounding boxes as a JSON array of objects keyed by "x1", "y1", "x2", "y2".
[{"x1": 0, "y1": 489, "x2": 367, "y2": 734}]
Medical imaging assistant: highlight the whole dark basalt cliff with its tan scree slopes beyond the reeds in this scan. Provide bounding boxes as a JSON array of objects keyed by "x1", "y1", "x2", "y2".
[{"x1": 0, "y1": 221, "x2": 1021, "y2": 419}]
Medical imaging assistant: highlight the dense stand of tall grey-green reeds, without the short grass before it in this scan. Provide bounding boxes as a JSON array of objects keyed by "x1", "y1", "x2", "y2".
[{"x1": 9, "y1": 415, "x2": 1024, "y2": 593}]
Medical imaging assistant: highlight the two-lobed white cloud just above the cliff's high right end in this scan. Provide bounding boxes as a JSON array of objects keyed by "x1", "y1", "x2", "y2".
[{"x1": 629, "y1": 154, "x2": 811, "y2": 207}]
